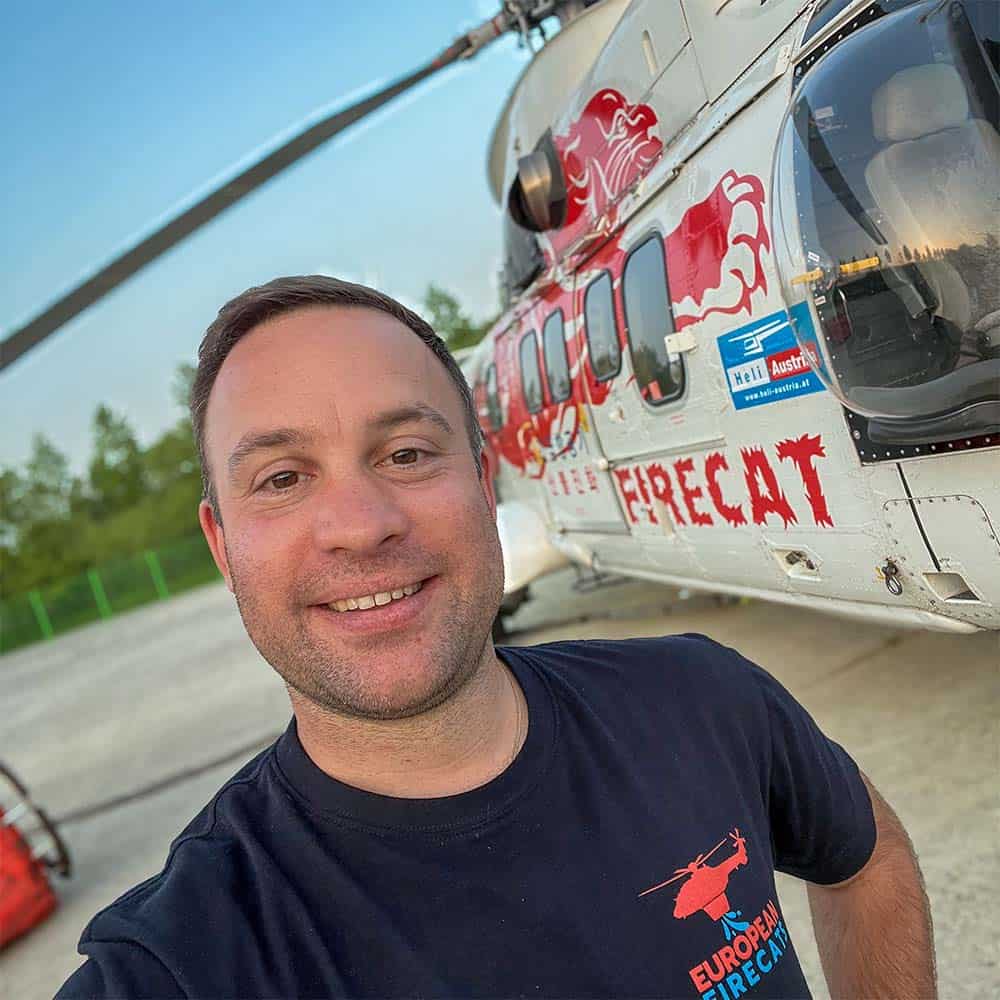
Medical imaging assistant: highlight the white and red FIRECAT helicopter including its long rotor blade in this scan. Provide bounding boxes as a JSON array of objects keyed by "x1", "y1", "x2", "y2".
[{"x1": 0, "y1": 0, "x2": 1000, "y2": 632}]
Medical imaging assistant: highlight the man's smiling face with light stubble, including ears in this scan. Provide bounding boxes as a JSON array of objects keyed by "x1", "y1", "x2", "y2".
[{"x1": 200, "y1": 307, "x2": 503, "y2": 718}]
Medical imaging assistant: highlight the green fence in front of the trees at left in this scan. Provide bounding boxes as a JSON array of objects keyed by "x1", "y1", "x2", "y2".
[{"x1": 0, "y1": 535, "x2": 219, "y2": 653}]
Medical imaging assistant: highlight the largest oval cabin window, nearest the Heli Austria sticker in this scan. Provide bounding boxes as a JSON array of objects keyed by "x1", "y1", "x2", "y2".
[{"x1": 622, "y1": 234, "x2": 684, "y2": 406}]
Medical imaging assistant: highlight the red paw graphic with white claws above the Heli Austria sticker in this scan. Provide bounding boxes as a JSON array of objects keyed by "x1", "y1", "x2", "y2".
[{"x1": 666, "y1": 170, "x2": 771, "y2": 330}]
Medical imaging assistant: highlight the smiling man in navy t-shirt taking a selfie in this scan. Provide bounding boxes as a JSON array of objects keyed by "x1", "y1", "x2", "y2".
[{"x1": 60, "y1": 277, "x2": 935, "y2": 1000}]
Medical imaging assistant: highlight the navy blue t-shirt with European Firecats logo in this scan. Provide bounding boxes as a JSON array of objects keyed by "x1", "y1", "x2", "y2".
[{"x1": 59, "y1": 636, "x2": 875, "y2": 1000}]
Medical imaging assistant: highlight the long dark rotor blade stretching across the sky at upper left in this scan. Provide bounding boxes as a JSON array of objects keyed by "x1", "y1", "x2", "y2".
[{"x1": 0, "y1": 14, "x2": 511, "y2": 371}]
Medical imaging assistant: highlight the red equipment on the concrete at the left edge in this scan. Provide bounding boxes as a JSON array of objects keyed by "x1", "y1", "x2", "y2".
[{"x1": 0, "y1": 764, "x2": 71, "y2": 948}]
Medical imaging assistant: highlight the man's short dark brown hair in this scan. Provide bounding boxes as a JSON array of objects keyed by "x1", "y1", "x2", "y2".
[{"x1": 190, "y1": 274, "x2": 483, "y2": 524}]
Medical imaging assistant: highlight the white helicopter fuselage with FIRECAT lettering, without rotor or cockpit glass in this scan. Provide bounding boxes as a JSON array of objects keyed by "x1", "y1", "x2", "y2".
[{"x1": 463, "y1": 0, "x2": 1000, "y2": 631}]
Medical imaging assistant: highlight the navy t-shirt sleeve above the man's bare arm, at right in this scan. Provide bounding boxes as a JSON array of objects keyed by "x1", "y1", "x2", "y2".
[{"x1": 751, "y1": 664, "x2": 875, "y2": 885}]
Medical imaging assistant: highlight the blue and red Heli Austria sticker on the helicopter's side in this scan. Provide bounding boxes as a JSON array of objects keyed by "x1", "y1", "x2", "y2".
[{"x1": 718, "y1": 302, "x2": 823, "y2": 410}]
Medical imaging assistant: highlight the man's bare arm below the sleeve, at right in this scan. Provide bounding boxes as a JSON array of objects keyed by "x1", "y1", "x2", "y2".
[{"x1": 808, "y1": 776, "x2": 937, "y2": 1000}]
